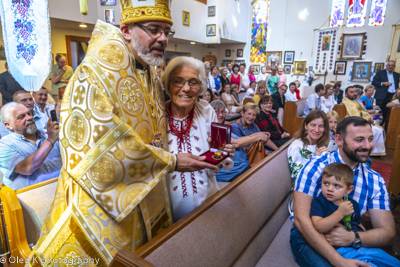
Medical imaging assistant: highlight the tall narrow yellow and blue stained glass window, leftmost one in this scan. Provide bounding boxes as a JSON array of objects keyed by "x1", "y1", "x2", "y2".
[{"x1": 250, "y1": 0, "x2": 269, "y2": 63}]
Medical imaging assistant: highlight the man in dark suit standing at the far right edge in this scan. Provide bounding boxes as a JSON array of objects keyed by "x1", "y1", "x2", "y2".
[{"x1": 372, "y1": 60, "x2": 400, "y2": 118}]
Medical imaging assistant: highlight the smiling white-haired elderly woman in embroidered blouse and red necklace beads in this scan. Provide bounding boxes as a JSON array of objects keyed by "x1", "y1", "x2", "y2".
[{"x1": 162, "y1": 57, "x2": 234, "y2": 221}]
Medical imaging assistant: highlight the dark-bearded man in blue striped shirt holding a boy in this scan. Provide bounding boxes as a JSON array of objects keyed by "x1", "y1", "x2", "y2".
[{"x1": 290, "y1": 117, "x2": 396, "y2": 267}]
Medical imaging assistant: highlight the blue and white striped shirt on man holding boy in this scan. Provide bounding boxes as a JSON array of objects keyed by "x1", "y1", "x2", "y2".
[{"x1": 291, "y1": 150, "x2": 390, "y2": 221}]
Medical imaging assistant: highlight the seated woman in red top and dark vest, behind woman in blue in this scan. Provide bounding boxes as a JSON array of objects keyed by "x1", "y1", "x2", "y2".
[{"x1": 256, "y1": 95, "x2": 290, "y2": 147}]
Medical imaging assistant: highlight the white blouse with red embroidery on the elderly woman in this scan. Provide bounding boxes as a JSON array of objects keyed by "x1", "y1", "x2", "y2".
[{"x1": 166, "y1": 99, "x2": 233, "y2": 222}]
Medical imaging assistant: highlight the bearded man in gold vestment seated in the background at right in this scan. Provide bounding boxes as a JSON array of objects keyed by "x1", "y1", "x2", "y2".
[{"x1": 342, "y1": 86, "x2": 386, "y2": 156}]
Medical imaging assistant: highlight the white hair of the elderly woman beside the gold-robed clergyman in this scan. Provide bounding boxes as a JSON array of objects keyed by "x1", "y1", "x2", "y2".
[{"x1": 161, "y1": 57, "x2": 207, "y2": 95}]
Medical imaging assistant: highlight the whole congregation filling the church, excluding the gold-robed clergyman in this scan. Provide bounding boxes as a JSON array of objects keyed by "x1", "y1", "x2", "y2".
[{"x1": 0, "y1": 36, "x2": 400, "y2": 266}]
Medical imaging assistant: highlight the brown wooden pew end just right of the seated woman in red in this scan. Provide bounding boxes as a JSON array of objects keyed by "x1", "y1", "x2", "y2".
[{"x1": 282, "y1": 98, "x2": 307, "y2": 136}]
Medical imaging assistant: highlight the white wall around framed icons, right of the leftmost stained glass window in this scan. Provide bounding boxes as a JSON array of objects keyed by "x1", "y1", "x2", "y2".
[{"x1": 262, "y1": 0, "x2": 400, "y2": 88}]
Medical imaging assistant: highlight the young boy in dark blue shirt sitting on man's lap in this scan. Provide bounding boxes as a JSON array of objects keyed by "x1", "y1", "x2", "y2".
[{"x1": 310, "y1": 163, "x2": 400, "y2": 267}]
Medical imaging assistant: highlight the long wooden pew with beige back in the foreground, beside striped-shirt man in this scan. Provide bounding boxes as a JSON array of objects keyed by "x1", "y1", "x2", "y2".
[{"x1": 111, "y1": 141, "x2": 297, "y2": 267}]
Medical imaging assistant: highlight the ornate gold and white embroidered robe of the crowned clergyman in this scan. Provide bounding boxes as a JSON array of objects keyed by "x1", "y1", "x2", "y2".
[{"x1": 30, "y1": 21, "x2": 175, "y2": 266}]
